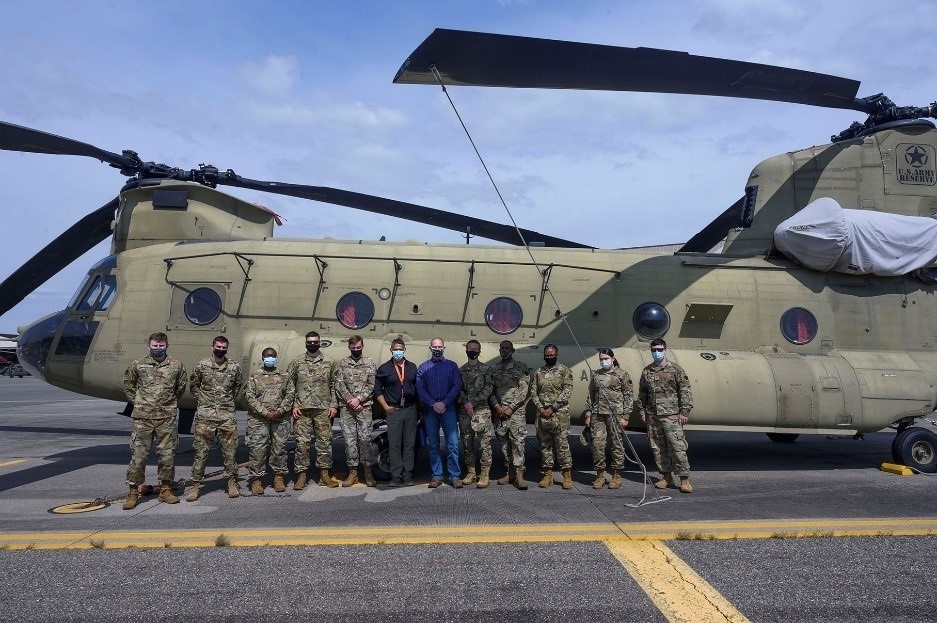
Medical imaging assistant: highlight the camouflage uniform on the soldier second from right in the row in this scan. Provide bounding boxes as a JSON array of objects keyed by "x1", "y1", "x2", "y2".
[{"x1": 586, "y1": 366, "x2": 634, "y2": 473}]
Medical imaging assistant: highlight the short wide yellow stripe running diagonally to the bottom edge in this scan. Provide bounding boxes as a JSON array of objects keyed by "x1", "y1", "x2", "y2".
[{"x1": 605, "y1": 541, "x2": 748, "y2": 623}]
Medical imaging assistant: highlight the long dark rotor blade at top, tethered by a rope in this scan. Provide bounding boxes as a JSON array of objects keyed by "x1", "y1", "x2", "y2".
[{"x1": 394, "y1": 28, "x2": 864, "y2": 110}]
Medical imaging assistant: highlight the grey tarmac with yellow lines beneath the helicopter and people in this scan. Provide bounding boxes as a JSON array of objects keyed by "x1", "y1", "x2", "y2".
[{"x1": 0, "y1": 377, "x2": 937, "y2": 621}]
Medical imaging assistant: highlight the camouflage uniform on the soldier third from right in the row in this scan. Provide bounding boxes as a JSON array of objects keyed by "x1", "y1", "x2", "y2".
[{"x1": 530, "y1": 363, "x2": 573, "y2": 472}]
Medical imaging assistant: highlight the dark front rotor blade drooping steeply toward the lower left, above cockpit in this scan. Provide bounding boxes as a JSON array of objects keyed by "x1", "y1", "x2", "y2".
[{"x1": 0, "y1": 197, "x2": 118, "y2": 316}]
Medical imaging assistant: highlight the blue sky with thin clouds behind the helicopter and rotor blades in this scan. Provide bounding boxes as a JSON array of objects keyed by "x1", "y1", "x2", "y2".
[{"x1": 0, "y1": 0, "x2": 937, "y2": 332}]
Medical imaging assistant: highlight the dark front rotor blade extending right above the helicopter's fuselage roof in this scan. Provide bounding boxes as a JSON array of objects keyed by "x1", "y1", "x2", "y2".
[{"x1": 217, "y1": 172, "x2": 592, "y2": 249}]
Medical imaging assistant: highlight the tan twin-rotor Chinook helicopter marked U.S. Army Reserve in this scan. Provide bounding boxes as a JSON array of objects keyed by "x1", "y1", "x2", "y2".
[{"x1": 0, "y1": 30, "x2": 937, "y2": 472}]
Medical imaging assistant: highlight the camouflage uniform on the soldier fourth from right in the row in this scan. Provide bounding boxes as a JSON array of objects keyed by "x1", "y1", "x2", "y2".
[{"x1": 490, "y1": 359, "x2": 530, "y2": 470}]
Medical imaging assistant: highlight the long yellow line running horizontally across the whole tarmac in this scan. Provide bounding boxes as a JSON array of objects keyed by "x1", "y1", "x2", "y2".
[{"x1": 0, "y1": 517, "x2": 937, "y2": 549}]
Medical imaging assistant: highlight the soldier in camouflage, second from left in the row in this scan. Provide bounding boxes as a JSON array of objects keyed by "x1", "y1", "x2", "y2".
[{"x1": 185, "y1": 335, "x2": 244, "y2": 502}]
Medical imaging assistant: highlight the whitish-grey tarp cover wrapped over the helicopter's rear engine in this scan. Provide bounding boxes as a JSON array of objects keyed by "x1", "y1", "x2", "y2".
[{"x1": 774, "y1": 197, "x2": 937, "y2": 276}]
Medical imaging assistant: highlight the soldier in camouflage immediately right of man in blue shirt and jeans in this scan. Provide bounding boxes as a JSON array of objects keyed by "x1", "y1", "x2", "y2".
[{"x1": 458, "y1": 340, "x2": 494, "y2": 489}]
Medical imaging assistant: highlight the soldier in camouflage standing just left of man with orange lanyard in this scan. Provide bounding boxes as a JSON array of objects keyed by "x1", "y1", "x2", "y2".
[{"x1": 335, "y1": 335, "x2": 377, "y2": 487}]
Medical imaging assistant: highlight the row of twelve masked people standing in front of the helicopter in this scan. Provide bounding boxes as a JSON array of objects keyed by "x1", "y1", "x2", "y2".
[{"x1": 123, "y1": 331, "x2": 692, "y2": 510}]
